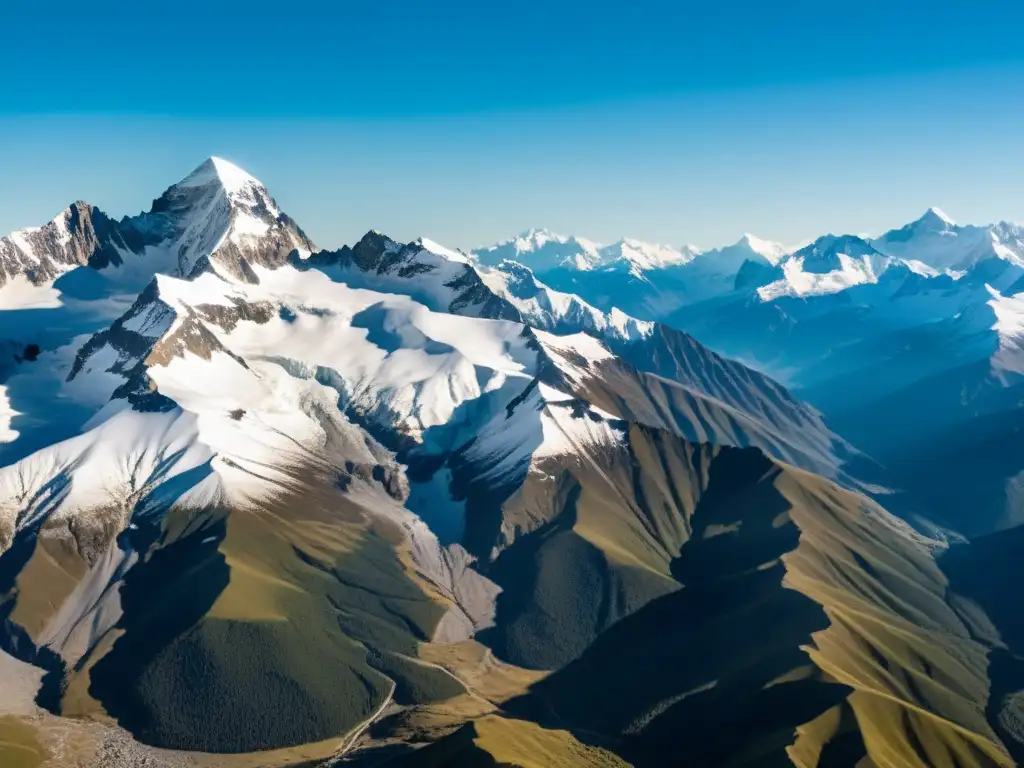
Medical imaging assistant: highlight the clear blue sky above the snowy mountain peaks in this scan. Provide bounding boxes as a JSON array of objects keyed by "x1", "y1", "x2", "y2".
[{"x1": 0, "y1": 0, "x2": 1024, "y2": 247}]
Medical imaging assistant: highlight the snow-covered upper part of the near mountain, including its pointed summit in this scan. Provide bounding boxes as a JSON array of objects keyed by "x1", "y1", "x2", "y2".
[{"x1": 0, "y1": 158, "x2": 864, "y2": 565}]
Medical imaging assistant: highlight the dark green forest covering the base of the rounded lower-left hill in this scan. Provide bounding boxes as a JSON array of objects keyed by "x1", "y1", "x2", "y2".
[{"x1": 101, "y1": 620, "x2": 388, "y2": 752}]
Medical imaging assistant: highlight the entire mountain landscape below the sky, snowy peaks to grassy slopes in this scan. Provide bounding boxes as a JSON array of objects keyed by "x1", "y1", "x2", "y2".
[{"x1": 0, "y1": 158, "x2": 1024, "y2": 768}]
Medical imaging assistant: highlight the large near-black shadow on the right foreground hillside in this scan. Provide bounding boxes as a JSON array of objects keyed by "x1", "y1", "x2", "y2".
[{"x1": 507, "y1": 449, "x2": 863, "y2": 767}]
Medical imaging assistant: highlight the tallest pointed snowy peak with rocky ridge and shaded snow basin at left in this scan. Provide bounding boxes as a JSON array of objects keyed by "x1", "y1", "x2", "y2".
[{"x1": 0, "y1": 158, "x2": 313, "y2": 473}]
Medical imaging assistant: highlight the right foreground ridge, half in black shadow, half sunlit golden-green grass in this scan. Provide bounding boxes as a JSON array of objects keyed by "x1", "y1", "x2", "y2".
[{"x1": 499, "y1": 449, "x2": 1012, "y2": 768}]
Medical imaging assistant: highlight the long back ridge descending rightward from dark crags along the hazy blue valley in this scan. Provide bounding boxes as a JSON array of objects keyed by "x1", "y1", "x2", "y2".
[{"x1": 305, "y1": 232, "x2": 855, "y2": 475}]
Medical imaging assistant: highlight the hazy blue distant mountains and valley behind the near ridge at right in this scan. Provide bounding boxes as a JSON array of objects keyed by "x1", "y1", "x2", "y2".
[{"x1": 478, "y1": 208, "x2": 1024, "y2": 534}]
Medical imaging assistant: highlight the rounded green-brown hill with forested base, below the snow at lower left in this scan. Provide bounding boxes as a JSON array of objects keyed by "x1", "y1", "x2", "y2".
[{"x1": 4, "y1": 472, "x2": 464, "y2": 753}]
